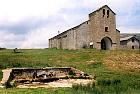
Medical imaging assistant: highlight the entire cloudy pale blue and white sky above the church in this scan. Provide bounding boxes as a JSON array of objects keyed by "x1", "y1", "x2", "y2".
[{"x1": 0, "y1": 0, "x2": 140, "y2": 48}]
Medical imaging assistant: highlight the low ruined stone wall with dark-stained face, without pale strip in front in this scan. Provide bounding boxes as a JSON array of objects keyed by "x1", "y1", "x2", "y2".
[{"x1": 1, "y1": 67, "x2": 90, "y2": 86}]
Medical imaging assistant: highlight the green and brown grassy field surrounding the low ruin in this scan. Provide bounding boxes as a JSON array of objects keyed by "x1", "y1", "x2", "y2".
[{"x1": 0, "y1": 49, "x2": 140, "y2": 94}]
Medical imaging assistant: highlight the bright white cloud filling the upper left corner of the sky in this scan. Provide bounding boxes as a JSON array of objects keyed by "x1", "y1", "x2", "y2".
[{"x1": 0, "y1": 0, "x2": 65, "y2": 21}]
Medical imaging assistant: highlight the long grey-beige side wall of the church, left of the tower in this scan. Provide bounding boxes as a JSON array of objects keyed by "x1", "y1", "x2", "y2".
[{"x1": 49, "y1": 21, "x2": 89, "y2": 49}]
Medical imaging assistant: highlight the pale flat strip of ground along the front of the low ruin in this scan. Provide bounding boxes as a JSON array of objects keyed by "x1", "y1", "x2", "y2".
[{"x1": 17, "y1": 79, "x2": 95, "y2": 88}]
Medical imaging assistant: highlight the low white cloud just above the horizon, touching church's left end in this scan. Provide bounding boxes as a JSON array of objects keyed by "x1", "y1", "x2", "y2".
[{"x1": 21, "y1": 28, "x2": 50, "y2": 48}]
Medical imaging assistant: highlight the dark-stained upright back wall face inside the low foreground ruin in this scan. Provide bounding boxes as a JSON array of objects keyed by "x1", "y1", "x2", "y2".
[{"x1": 11, "y1": 68, "x2": 71, "y2": 81}]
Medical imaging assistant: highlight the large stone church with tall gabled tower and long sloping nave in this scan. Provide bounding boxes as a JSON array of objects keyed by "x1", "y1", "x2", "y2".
[{"x1": 49, "y1": 5, "x2": 120, "y2": 50}]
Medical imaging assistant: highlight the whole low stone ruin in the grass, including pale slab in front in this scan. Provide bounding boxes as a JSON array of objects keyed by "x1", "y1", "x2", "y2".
[{"x1": 0, "y1": 67, "x2": 95, "y2": 88}]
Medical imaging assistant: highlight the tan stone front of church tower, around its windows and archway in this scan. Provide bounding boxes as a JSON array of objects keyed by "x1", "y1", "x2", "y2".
[{"x1": 89, "y1": 6, "x2": 120, "y2": 50}]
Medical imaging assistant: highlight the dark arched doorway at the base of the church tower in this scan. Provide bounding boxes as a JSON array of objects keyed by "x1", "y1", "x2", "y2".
[{"x1": 101, "y1": 37, "x2": 112, "y2": 50}]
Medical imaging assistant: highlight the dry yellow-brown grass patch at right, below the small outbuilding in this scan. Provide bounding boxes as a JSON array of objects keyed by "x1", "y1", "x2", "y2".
[{"x1": 104, "y1": 51, "x2": 140, "y2": 72}]
